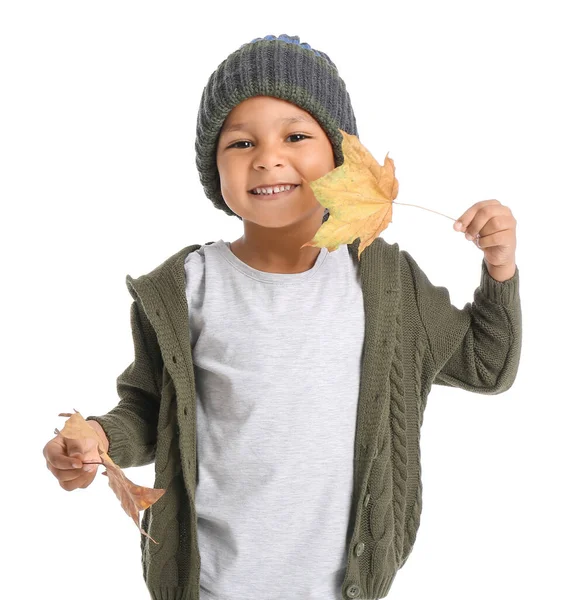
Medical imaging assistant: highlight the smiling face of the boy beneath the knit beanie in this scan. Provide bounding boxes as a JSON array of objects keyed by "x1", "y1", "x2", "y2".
[{"x1": 217, "y1": 96, "x2": 335, "y2": 226}]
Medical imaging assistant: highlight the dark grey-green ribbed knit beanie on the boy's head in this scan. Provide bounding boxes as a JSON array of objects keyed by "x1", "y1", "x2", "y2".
[{"x1": 195, "y1": 34, "x2": 359, "y2": 221}]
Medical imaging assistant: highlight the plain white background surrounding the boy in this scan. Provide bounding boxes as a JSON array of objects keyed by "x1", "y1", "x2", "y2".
[{"x1": 0, "y1": 0, "x2": 568, "y2": 600}]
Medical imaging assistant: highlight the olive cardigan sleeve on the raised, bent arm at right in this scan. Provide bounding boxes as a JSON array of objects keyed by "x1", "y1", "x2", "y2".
[{"x1": 402, "y1": 251, "x2": 522, "y2": 394}]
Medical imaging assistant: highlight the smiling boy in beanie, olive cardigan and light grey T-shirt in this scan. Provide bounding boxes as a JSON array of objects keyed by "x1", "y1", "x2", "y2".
[{"x1": 44, "y1": 35, "x2": 521, "y2": 600}]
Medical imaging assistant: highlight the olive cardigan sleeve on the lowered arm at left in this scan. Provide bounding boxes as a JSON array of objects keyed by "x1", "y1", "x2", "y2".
[{"x1": 87, "y1": 301, "x2": 163, "y2": 468}]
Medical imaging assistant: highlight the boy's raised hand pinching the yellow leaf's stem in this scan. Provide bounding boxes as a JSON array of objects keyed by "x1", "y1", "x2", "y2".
[{"x1": 454, "y1": 200, "x2": 517, "y2": 271}]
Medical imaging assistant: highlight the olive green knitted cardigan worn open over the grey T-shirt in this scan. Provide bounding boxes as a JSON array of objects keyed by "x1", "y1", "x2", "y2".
[{"x1": 87, "y1": 237, "x2": 521, "y2": 600}]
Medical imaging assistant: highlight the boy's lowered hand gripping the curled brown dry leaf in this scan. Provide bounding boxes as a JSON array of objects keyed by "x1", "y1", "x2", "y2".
[{"x1": 43, "y1": 422, "x2": 101, "y2": 492}]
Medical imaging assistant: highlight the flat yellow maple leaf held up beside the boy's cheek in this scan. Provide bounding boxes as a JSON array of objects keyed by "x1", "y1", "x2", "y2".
[{"x1": 301, "y1": 129, "x2": 398, "y2": 260}]
